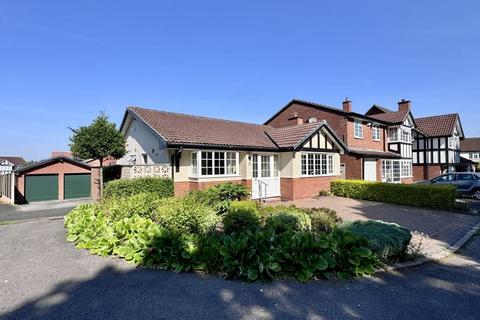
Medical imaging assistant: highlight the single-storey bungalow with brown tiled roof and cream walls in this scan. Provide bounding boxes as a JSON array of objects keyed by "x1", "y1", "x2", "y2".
[{"x1": 117, "y1": 107, "x2": 347, "y2": 200}]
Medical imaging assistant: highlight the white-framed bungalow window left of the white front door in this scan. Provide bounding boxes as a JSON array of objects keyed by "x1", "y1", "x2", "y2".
[{"x1": 190, "y1": 151, "x2": 238, "y2": 176}]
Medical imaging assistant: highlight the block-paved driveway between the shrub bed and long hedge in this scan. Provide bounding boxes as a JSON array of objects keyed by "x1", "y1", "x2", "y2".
[{"x1": 289, "y1": 196, "x2": 480, "y2": 245}]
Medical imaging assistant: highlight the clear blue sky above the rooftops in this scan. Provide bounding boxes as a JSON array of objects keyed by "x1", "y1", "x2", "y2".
[{"x1": 0, "y1": 0, "x2": 480, "y2": 159}]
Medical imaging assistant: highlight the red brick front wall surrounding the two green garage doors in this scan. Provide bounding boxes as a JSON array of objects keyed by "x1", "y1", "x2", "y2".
[{"x1": 16, "y1": 161, "x2": 93, "y2": 203}]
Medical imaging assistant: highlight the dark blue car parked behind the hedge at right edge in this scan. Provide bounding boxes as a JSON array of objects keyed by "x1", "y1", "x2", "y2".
[{"x1": 419, "y1": 172, "x2": 480, "y2": 200}]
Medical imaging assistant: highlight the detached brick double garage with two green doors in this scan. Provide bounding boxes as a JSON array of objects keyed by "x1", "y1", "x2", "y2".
[{"x1": 15, "y1": 156, "x2": 99, "y2": 204}]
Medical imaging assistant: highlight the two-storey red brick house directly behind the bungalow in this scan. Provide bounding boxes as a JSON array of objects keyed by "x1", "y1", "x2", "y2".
[{"x1": 265, "y1": 99, "x2": 414, "y2": 183}]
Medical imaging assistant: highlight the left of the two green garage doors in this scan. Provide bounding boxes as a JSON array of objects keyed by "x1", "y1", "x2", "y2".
[{"x1": 25, "y1": 174, "x2": 58, "y2": 202}]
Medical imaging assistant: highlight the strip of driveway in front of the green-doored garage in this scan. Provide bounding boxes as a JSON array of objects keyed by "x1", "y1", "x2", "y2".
[{"x1": 0, "y1": 199, "x2": 91, "y2": 223}]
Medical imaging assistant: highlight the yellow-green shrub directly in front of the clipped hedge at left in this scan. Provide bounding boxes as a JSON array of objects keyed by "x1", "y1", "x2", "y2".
[{"x1": 101, "y1": 193, "x2": 163, "y2": 220}]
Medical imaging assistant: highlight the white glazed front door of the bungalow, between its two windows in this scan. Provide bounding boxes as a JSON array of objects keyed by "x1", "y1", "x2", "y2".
[{"x1": 252, "y1": 154, "x2": 280, "y2": 199}]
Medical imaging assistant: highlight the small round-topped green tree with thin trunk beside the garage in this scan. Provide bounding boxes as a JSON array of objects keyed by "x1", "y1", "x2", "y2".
[{"x1": 70, "y1": 112, "x2": 126, "y2": 194}]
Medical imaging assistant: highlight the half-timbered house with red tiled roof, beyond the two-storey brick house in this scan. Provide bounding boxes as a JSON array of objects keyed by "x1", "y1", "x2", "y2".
[{"x1": 413, "y1": 113, "x2": 464, "y2": 181}]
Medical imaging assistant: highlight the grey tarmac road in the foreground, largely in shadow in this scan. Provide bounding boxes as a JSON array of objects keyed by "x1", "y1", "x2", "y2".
[{"x1": 0, "y1": 219, "x2": 480, "y2": 320}]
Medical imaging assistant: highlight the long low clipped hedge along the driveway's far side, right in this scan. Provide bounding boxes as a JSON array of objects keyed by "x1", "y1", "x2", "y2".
[{"x1": 330, "y1": 180, "x2": 456, "y2": 210}]
